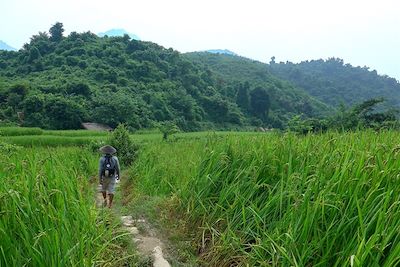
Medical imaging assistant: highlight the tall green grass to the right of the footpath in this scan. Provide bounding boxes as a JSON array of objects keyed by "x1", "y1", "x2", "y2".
[{"x1": 135, "y1": 131, "x2": 400, "y2": 266}]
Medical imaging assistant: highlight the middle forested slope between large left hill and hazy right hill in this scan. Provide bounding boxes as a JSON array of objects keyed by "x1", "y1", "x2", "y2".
[{"x1": 185, "y1": 52, "x2": 333, "y2": 124}]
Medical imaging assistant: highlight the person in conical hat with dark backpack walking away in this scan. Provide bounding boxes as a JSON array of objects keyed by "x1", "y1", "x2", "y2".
[{"x1": 99, "y1": 145, "x2": 120, "y2": 208}]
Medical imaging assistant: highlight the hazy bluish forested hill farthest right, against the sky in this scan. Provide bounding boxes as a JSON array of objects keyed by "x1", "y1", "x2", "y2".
[{"x1": 268, "y1": 58, "x2": 400, "y2": 108}]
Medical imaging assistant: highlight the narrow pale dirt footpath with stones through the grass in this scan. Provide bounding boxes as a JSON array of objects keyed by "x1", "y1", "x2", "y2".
[{"x1": 96, "y1": 178, "x2": 171, "y2": 267}]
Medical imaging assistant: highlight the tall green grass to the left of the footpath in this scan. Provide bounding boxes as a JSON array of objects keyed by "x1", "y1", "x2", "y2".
[{"x1": 0, "y1": 148, "x2": 125, "y2": 266}]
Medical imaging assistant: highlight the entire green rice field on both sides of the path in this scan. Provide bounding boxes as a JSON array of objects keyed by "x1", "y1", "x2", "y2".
[{"x1": 0, "y1": 129, "x2": 400, "y2": 266}]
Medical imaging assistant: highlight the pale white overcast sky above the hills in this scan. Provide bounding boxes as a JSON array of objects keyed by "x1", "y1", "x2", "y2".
[{"x1": 0, "y1": 0, "x2": 400, "y2": 80}]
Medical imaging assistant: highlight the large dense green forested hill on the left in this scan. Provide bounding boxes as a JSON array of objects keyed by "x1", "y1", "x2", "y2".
[{"x1": 0, "y1": 28, "x2": 246, "y2": 130}]
